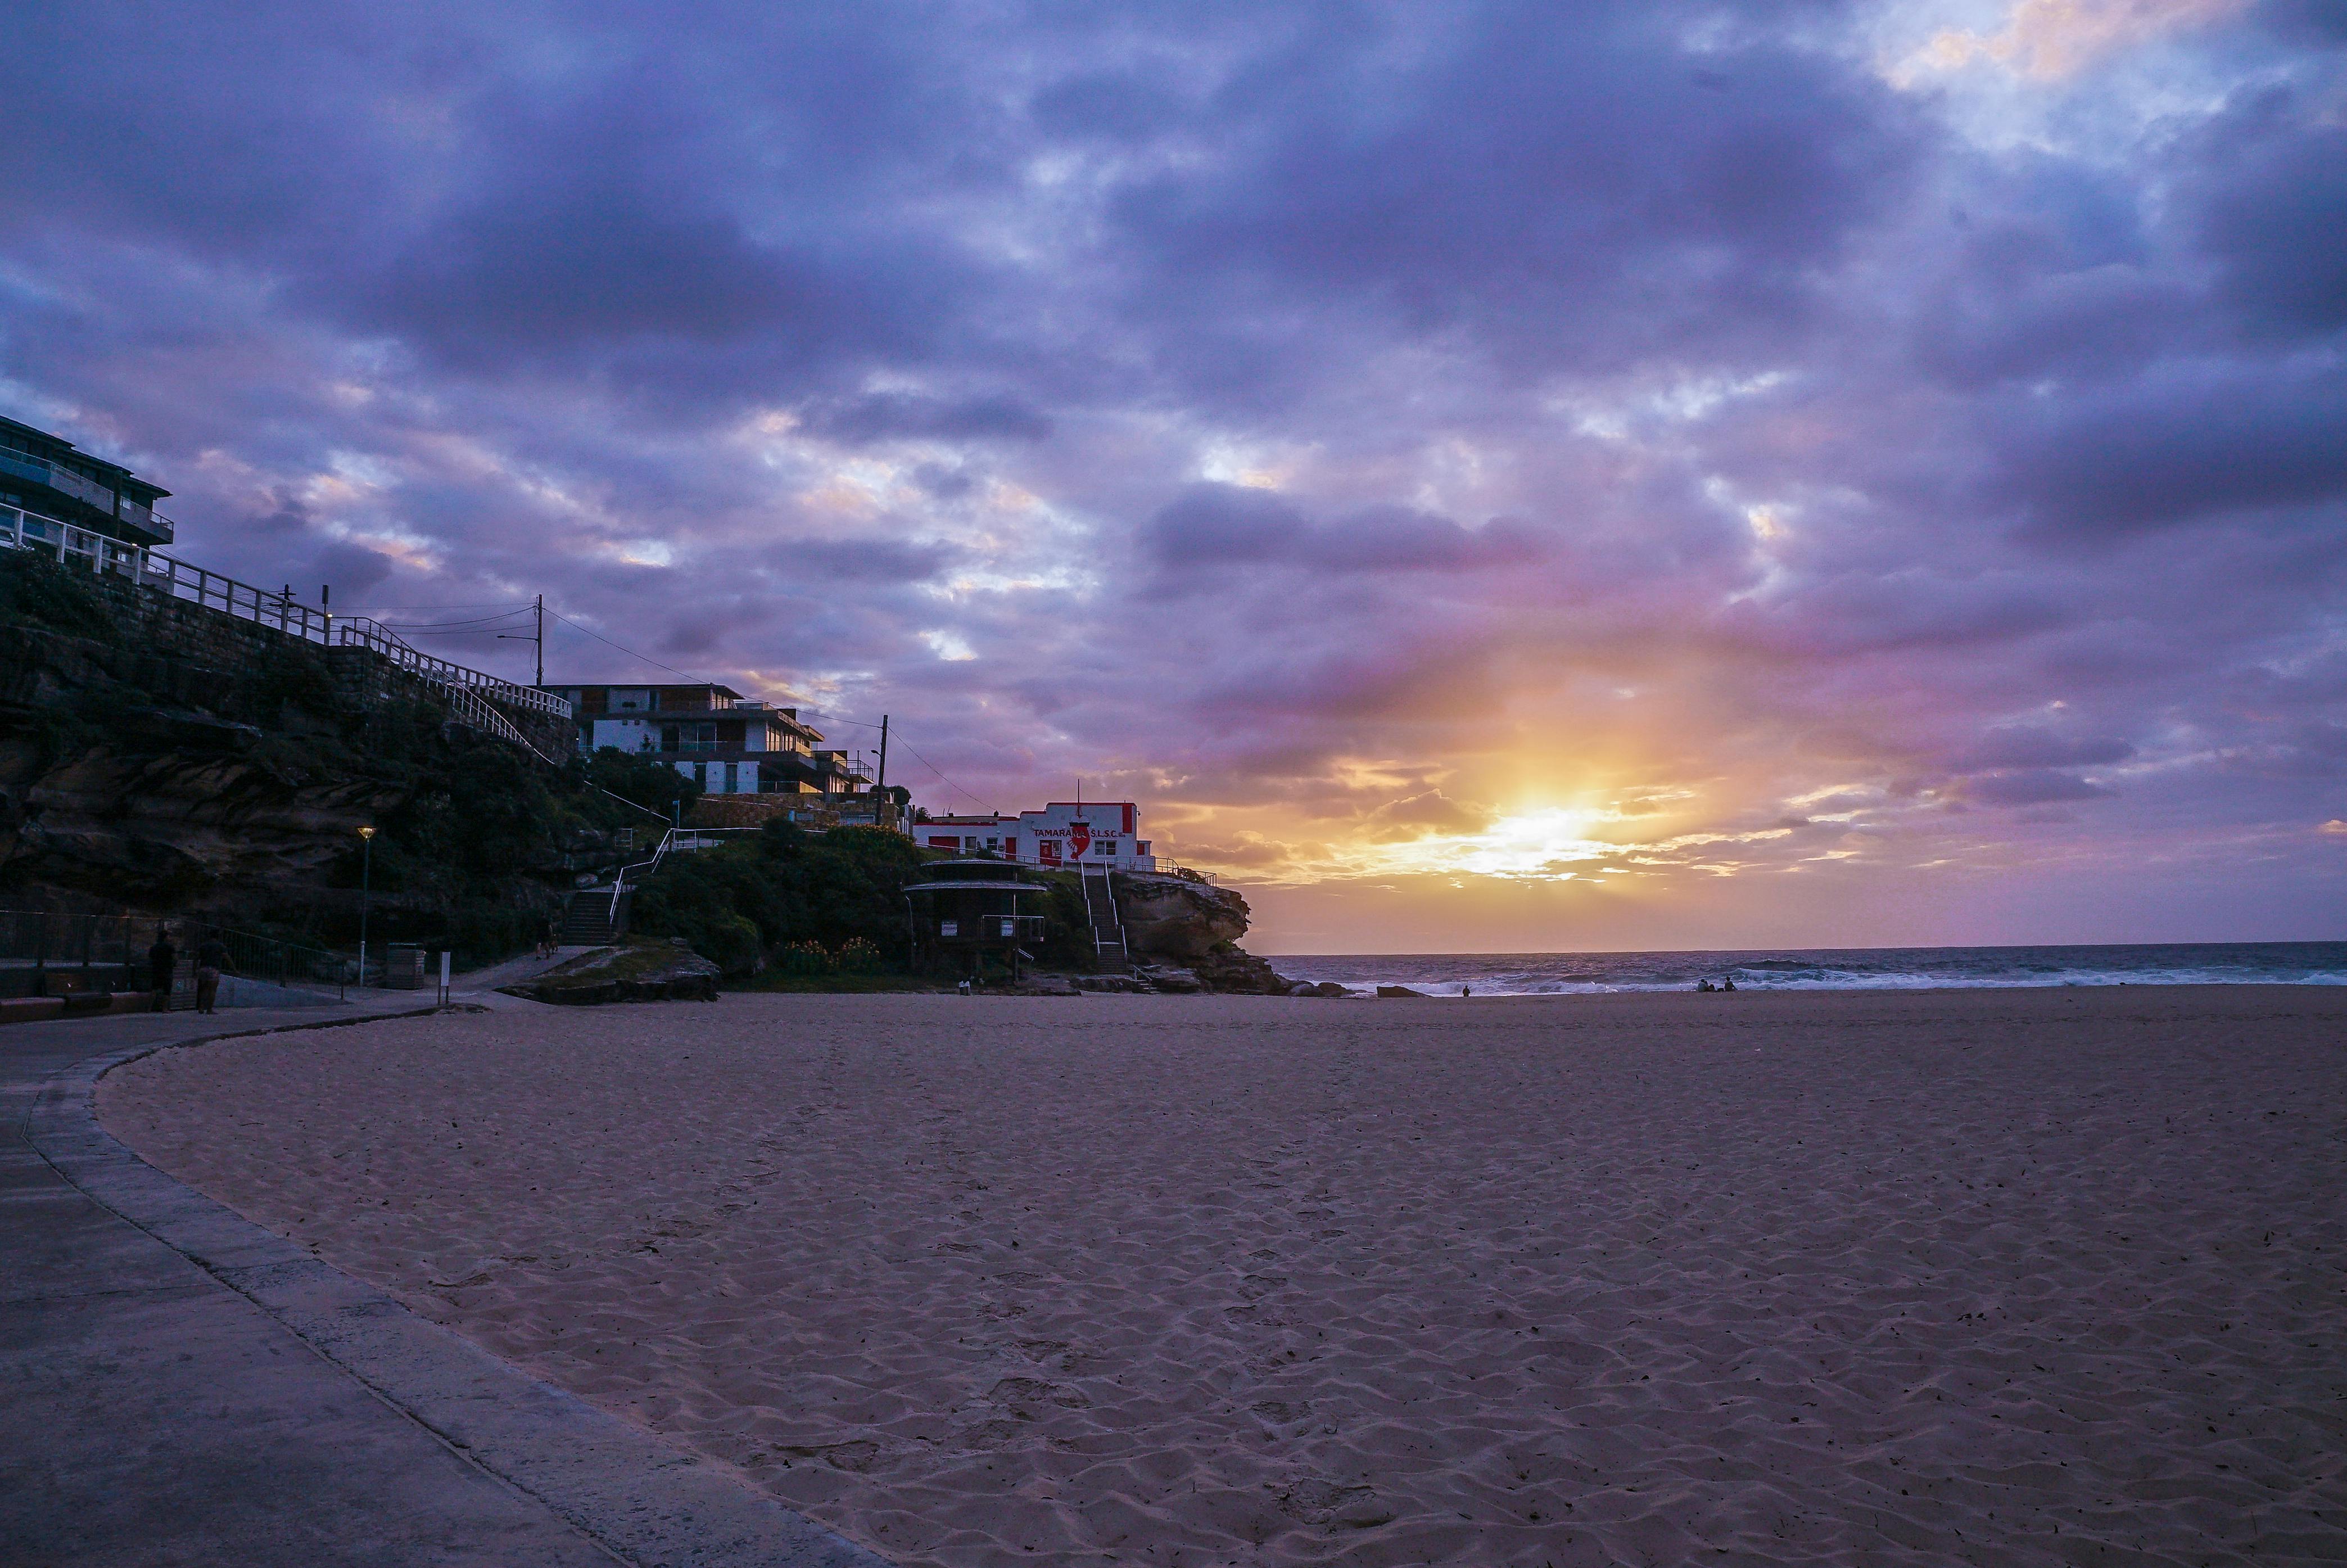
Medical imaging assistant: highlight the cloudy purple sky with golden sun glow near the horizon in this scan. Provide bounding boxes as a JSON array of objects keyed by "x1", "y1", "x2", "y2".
[{"x1": 0, "y1": 0, "x2": 2347, "y2": 953}]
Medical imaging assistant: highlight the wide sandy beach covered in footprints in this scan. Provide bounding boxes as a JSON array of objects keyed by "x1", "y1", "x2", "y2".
[{"x1": 98, "y1": 986, "x2": 2347, "y2": 1568}]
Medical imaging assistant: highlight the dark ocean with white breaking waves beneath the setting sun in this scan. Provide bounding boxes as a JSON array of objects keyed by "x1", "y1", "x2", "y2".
[{"x1": 1268, "y1": 941, "x2": 2347, "y2": 995}]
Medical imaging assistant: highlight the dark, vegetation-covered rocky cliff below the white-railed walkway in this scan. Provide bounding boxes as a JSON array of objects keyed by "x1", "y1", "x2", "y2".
[{"x1": 0, "y1": 552, "x2": 662, "y2": 957}]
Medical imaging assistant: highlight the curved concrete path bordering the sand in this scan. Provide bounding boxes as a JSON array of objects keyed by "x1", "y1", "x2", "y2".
[{"x1": 0, "y1": 993, "x2": 887, "y2": 1568}]
